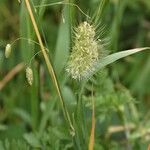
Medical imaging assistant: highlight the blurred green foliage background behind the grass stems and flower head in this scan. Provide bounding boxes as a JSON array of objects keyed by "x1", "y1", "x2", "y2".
[{"x1": 0, "y1": 0, "x2": 150, "y2": 150}]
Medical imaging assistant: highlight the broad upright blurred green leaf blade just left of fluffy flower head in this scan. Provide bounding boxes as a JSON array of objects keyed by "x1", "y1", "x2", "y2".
[{"x1": 54, "y1": 6, "x2": 70, "y2": 75}]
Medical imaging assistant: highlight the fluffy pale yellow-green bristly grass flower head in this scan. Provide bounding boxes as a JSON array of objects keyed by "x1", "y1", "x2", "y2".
[{"x1": 66, "y1": 21, "x2": 99, "y2": 80}]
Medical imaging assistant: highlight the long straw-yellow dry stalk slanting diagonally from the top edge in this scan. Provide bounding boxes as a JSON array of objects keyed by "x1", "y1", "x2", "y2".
[{"x1": 25, "y1": 0, "x2": 74, "y2": 131}]
